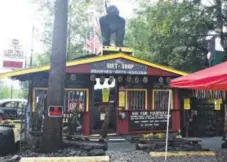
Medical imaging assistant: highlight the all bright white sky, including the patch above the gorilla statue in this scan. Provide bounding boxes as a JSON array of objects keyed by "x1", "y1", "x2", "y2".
[{"x1": 0, "y1": 0, "x2": 215, "y2": 73}]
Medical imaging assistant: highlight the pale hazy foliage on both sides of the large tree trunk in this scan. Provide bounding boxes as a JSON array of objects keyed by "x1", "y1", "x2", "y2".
[{"x1": 33, "y1": 0, "x2": 104, "y2": 66}]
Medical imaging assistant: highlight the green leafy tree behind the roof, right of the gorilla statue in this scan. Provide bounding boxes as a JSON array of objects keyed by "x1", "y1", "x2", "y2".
[{"x1": 127, "y1": 2, "x2": 214, "y2": 72}]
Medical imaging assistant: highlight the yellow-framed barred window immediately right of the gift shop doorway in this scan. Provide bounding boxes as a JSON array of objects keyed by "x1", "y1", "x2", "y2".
[{"x1": 126, "y1": 89, "x2": 147, "y2": 110}]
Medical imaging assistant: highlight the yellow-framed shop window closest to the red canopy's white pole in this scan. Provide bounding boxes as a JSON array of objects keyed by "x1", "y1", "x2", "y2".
[{"x1": 152, "y1": 89, "x2": 173, "y2": 110}]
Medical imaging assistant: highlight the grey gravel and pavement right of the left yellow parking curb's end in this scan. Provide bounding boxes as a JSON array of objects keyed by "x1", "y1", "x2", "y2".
[{"x1": 107, "y1": 137, "x2": 227, "y2": 162}]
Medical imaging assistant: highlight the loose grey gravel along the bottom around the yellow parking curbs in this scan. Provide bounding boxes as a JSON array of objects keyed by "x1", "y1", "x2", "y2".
[{"x1": 0, "y1": 148, "x2": 227, "y2": 162}]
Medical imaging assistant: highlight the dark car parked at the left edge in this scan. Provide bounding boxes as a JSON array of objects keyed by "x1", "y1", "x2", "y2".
[{"x1": 0, "y1": 99, "x2": 27, "y2": 120}]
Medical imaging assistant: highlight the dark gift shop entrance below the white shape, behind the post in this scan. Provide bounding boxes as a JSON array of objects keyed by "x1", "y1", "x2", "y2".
[{"x1": 91, "y1": 88, "x2": 117, "y2": 134}]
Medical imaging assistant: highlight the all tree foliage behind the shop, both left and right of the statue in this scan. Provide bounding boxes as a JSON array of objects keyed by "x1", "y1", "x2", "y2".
[{"x1": 33, "y1": 0, "x2": 227, "y2": 72}]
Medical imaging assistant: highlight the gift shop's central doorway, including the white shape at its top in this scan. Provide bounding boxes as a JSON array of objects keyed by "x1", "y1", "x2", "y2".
[{"x1": 91, "y1": 78, "x2": 117, "y2": 134}]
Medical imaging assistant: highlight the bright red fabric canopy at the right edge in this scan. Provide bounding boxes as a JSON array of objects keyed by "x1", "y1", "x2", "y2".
[{"x1": 170, "y1": 62, "x2": 227, "y2": 90}]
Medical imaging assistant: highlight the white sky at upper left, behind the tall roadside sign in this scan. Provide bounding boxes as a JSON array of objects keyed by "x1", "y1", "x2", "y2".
[{"x1": 0, "y1": 0, "x2": 41, "y2": 72}]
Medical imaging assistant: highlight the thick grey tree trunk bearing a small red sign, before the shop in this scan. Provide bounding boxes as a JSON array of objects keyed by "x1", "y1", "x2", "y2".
[{"x1": 41, "y1": 0, "x2": 68, "y2": 152}]
